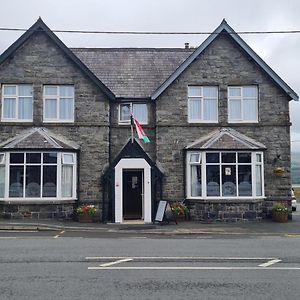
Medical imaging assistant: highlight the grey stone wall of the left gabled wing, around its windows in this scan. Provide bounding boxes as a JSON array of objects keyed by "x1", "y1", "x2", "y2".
[{"x1": 0, "y1": 33, "x2": 109, "y2": 216}]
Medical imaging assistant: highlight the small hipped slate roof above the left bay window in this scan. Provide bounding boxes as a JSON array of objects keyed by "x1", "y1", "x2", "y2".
[{"x1": 0, "y1": 128, "x2": 79, "y2": 150}]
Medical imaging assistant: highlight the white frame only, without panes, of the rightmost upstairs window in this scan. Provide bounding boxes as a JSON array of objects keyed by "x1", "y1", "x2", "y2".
[{"x1": 227, "y1": 85, "x2": 259, "y2": 123}]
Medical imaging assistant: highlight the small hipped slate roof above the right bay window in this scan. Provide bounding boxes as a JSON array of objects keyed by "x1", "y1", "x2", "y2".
[{"x1": 185, "y1": 128, "x2": 266, "y2": 150}]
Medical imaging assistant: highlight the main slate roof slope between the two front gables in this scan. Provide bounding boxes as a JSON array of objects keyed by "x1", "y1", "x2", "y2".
[{"x1": 71, "y1": 48, "x2": 195, "y2": 98}]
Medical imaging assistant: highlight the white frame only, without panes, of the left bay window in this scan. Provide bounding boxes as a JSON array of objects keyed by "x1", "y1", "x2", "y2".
[{"x1": 0, "y1": 150, "x2": 77, "y2": 202}]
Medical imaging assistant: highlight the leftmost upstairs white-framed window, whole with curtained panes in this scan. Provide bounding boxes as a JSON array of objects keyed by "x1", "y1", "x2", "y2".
[{"x1": 1, "y1": 84, "x2": 33, "y2": 122}]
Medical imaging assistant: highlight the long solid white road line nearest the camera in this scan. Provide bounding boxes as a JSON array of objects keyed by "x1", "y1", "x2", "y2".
[{"x1": 88, "y1": 267, "x2": 300, "y2": 271}]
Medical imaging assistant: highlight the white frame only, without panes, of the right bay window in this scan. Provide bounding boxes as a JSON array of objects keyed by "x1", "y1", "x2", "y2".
[{"x1": 186, "y1": 150, "x2": 265, "y2": 200}]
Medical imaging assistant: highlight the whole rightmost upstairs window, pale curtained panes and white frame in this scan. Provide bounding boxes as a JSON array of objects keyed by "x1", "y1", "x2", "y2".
[{"x1": 228, "y1": 85, "x2": 258, "y2": 123}]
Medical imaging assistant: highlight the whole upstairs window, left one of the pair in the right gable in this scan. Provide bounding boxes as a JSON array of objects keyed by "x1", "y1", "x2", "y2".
[{"x1": 188, "y1": 86, "x2": 218, "y2": 123}]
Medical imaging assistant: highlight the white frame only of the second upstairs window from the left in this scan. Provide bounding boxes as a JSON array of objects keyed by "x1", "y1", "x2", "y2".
[{"x1": 43, "y1": 84, "x2": 75, "y2": 123}]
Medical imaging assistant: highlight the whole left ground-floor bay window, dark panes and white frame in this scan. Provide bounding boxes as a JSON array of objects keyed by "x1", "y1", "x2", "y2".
[{"x1": 0, "y1": 151, "x2": 76, "y2": 201}]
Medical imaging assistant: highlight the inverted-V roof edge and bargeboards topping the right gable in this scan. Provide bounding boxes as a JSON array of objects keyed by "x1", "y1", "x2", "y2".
[{"x1": 151, "y1": 20, "x2": 299, "y2": 101}]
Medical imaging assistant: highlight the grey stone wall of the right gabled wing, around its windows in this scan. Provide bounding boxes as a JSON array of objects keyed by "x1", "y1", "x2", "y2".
[{"x1": 156, "y1": 35, "x2": 291, "y2": 219}]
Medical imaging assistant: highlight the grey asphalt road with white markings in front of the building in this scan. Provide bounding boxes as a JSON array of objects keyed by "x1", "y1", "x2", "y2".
[{"x1": 0, "y1": 231, "x2": 300, "y2": 300}]
